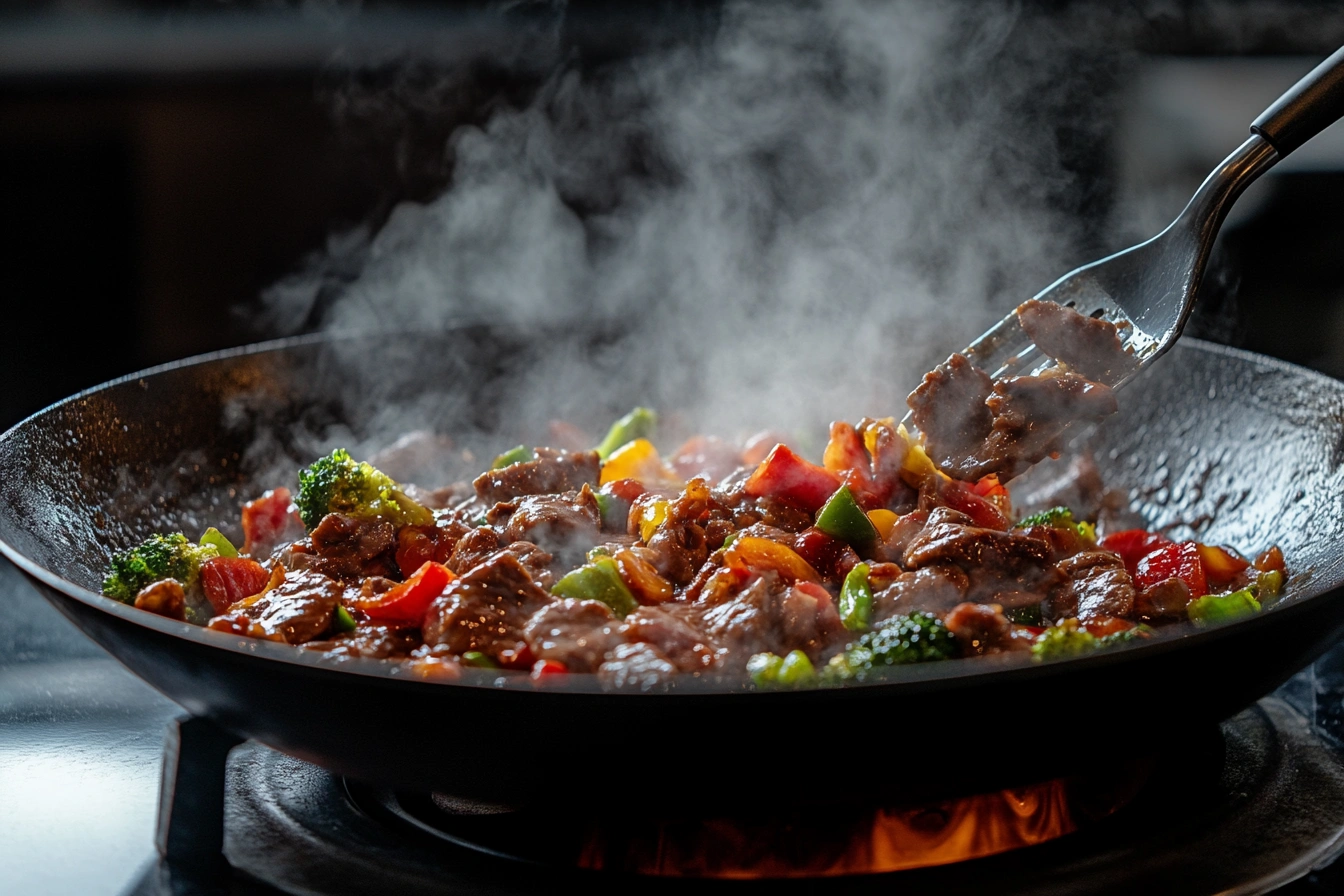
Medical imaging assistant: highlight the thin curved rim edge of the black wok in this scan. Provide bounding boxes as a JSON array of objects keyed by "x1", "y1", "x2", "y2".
[{"x1": 0, "y1": 333, "x2": 1344, "y2": 700}]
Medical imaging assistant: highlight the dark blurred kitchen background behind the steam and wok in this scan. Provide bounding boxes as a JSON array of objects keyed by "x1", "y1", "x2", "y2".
[{"x1": 0, "y1": 0, "x2": 1344, "y2": 427}]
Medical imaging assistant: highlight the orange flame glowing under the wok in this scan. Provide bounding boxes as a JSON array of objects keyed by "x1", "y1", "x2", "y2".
[{"x1": 578, "y1": 775, "x2": 1146, "y2": 879}]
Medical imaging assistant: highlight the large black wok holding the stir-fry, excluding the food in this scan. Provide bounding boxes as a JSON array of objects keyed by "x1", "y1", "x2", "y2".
[{"x1": 0, "y1": 328, "x2": 1344, "y2": 809}]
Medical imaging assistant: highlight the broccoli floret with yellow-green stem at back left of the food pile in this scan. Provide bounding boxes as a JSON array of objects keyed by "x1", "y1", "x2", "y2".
[{"x1": 294, "y1": 449, "x2": 434, "y2": 529}]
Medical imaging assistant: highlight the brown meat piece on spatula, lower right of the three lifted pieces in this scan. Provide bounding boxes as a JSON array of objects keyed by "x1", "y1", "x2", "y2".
[{"x1": 968, "y1": 369, "x2": 1118, "y2": 480}]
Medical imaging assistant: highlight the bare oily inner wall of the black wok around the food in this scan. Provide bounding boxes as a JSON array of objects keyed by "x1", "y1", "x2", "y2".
[{"x1": 0, "y1": 328, "x2": 1344, "y2": 636}]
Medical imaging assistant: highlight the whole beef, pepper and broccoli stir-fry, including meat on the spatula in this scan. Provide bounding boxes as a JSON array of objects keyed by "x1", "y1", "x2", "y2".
[{"x1": 103, "y1": 302, "x2": 1285, "y2": 689}]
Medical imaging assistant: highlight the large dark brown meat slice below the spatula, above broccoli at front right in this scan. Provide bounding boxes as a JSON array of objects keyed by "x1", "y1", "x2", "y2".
[{"x1": 903, "y1": 508, "x2": 1060, "y2": 607}]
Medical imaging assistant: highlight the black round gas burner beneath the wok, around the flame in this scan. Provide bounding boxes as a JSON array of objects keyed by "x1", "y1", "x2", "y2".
[{"x1": 131, "y1": 697, "x2": 1344, "y2": 895}]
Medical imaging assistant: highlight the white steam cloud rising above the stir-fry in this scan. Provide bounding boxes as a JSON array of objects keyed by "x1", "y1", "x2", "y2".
[{"x1": 252, "y1": 3, "x2": 1118, "y2": 459}]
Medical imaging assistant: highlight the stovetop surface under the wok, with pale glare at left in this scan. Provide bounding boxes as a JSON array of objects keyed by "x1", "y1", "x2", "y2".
[{"x1": 0, "y1": 564, "x2": 1344, "y2": 896}]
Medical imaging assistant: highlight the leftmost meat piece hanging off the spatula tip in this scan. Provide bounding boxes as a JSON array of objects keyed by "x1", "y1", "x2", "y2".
[{"x1": 906, "y1": 355, "x2": 993, "y2": 478}]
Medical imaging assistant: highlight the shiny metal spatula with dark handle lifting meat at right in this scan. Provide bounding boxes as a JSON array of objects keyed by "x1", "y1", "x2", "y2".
[{"x1": 924, "y1": 47, "x2": 1344, "y2": 402}]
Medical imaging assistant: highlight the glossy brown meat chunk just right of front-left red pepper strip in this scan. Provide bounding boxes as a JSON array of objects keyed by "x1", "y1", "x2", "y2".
[{"x1": 425, "y1": 551, "x2": 554, "y2": 657}]
